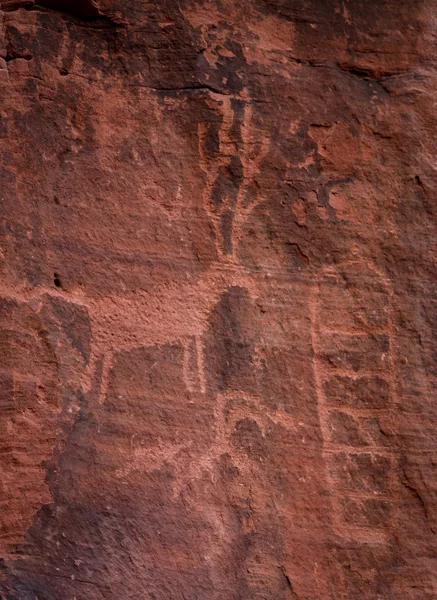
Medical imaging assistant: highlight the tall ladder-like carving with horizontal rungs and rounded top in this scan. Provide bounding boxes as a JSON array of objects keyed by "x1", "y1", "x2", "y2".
[{"x1": 311, "y1": 262, "x2": 398, "y2": 543}]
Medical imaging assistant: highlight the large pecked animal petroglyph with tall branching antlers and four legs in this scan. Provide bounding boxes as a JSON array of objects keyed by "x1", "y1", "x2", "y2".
[{"x1": 79, "y1": 93, "x2": 269, "y2": 406}]
